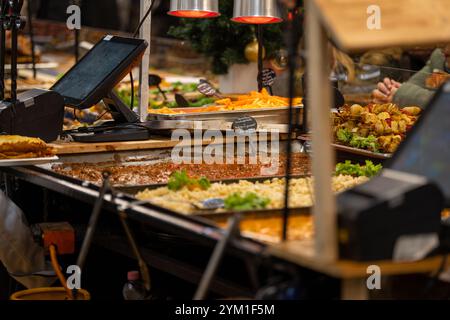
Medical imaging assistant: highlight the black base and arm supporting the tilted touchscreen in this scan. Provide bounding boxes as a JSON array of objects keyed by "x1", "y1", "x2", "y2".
[{"x1": 64, "y1": 91, "x2": 154, "y2": 143}]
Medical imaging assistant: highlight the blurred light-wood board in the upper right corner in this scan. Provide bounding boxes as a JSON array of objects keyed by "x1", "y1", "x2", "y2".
[{"x1": 314, "y1": 0, "x2": 450, "y2": 51}]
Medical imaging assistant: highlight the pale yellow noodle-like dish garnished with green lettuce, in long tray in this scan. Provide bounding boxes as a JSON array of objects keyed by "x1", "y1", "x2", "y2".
[{"x1": 136, "y1": 175, "x2": 368, "y2": 214}]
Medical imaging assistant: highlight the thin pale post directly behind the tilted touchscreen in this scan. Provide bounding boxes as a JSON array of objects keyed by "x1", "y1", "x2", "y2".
[{"x1": 139, "y1": 0, "x2": 155, "y2": 121}]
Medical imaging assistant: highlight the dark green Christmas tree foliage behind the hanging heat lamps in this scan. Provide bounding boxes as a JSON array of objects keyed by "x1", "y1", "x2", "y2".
[{"x1": 168, "y1": 0, "x2": 283, "y2": 74}]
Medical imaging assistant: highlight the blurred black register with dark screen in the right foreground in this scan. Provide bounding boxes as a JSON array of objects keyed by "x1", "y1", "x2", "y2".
[{"x1": 337, "y1": 82, "x2": 450, "y2": 261}]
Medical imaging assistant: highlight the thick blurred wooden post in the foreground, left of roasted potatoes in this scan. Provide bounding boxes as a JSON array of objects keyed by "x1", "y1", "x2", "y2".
[{"x1": 305, "y1": 0, "x2": 337, "y2": 261}]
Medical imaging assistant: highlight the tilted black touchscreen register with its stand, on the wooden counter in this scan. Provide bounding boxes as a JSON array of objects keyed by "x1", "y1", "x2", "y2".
[{"x1": 50, "y1": 35, "x2": 152, "y2": 142}]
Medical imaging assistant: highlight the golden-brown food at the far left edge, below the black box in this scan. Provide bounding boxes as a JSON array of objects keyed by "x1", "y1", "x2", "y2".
[{"x1": 0, "y1": 135, "x2": 54, "y2": 159}]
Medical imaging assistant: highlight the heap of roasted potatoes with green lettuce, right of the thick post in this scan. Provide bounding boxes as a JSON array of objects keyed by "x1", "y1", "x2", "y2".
[{"x1": 333, "y1": 103, "x2": 421, "y2": 153}]
